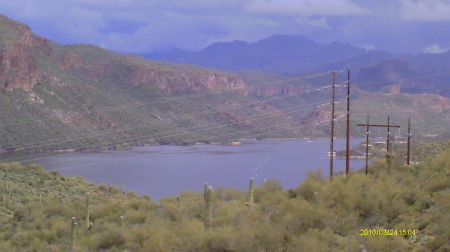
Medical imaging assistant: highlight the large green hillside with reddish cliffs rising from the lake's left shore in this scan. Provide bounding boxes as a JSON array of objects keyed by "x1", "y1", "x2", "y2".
[{"x1": 0, "y1": 16, "x2": 301, "y2": 151}]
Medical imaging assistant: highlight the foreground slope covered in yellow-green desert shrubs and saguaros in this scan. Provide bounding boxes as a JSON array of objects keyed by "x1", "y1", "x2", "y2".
[{"x1": 0, "y1": 147, "x2": 450, "y2": 251}]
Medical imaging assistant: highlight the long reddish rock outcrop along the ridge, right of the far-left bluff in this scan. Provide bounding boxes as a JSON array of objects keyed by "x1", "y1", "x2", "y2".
[{"x1": 58, "y1": 52, "x2": 248, "y2": 95}]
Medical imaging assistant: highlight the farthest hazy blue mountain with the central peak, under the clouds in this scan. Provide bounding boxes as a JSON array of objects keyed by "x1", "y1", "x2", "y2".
[{"x1": 142, "y1": 35, "x2": 376, "y2": 75}]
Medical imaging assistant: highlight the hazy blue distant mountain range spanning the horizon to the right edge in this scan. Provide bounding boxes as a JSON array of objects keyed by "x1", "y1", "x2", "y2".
[{"x1": 142, "y1": 35, "x2": 450, "y2": 97}]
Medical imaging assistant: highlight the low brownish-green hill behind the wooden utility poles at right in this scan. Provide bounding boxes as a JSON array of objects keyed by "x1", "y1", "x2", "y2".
[{"x1": 302, "y1": 93, "x2": 450, "y2": 140}]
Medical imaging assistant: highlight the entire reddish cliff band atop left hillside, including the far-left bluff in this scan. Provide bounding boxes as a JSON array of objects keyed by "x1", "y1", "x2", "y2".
[{"x1": 0, "y1": 16, "x2": 248, "y2": 95}]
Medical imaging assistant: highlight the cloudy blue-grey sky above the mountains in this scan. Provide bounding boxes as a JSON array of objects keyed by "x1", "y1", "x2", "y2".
[{"x1": 0, "y1": 0, "x2": 450, "y2": 54}]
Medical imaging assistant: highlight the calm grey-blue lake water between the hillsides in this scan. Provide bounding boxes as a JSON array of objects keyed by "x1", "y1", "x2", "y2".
[{"x1": 0, "y1": 139, "x2": 365, "y2": 200}]
